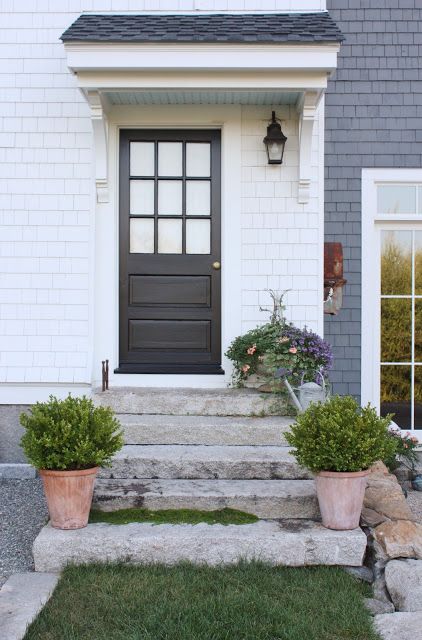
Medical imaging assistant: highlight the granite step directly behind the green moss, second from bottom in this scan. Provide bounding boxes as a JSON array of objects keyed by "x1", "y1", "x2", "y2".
[{"x1": 93, "y1": 480, "x2": 320, "y2": 520}]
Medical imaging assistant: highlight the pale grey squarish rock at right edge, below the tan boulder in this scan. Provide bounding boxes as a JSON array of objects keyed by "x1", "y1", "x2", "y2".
[{"x1": 385, "y1": 560, "x2": 422, "y2": 611}]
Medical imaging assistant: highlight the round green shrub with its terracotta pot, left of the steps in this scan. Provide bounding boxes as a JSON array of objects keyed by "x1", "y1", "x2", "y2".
[{"x1": 20, "y1": 395, "x2": 123, "y2": 529}]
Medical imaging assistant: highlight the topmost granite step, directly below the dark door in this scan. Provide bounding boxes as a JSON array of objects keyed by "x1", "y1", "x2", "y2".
[{"x1": 92, "y1": 387, "x2": 291, "y2": 416}]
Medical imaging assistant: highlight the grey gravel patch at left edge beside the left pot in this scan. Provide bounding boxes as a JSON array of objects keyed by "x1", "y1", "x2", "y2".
[{"x1": 0, "y1": 478, "x2": 48, "y2": 586}]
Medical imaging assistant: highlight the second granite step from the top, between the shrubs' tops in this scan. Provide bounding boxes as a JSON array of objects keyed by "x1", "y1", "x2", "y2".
[{"x1": 116, "y1": 414, "x2": 294, "y2": 446}]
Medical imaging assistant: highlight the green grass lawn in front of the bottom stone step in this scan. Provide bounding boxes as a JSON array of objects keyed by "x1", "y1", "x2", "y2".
[{"x1": 24, "y1": 563, "x2": 378, "y2": 640}]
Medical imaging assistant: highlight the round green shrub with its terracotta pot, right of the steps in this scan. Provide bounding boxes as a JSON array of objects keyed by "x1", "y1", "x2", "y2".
[{"x1": 286, "y1": 396, "x2": 396, "y2": 530}]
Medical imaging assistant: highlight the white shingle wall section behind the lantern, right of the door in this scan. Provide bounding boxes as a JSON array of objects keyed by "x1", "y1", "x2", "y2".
[{"x1": 242, "y1": 106, "x2": 322, "y2": 330}]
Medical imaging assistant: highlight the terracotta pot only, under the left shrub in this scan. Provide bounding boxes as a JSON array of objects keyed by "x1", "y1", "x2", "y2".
[{"x1": 40, "y1": 467, "x2": 98, "y2": 529}]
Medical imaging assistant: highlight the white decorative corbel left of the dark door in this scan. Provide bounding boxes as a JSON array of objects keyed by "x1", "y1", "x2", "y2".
[{"x1": 86, "y1": 91, "x2": 109, "y2": 202}]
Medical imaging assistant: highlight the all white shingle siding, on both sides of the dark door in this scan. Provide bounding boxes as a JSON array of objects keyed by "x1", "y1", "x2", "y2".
[{"x1": 0, "y1": 0, "x2": 325, "y2": 384}]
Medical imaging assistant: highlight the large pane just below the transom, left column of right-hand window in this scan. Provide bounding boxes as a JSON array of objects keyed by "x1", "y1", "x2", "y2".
[{"x1": 381, "y1": 231, "x2": 412, "y2": 295}]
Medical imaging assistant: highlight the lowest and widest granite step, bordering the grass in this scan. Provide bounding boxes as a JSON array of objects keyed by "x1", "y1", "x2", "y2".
[{"x1": 33, "y1": 520, "x2": 366, "y2": 571}]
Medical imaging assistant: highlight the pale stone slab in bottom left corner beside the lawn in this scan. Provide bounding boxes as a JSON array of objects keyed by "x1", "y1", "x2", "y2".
[{"x1": 0, "y1": 573, "x2": 59, "y2": 640}]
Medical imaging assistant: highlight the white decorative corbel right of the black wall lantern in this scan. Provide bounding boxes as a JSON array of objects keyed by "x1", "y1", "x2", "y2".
[{"x1": 297, "y1": 91, "x2": 322, "y2": 204}]
